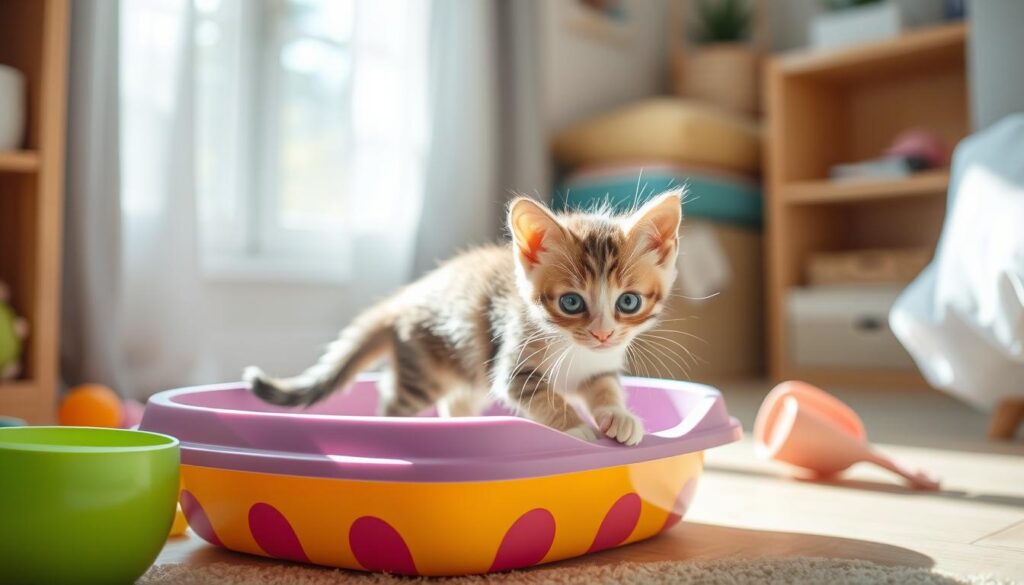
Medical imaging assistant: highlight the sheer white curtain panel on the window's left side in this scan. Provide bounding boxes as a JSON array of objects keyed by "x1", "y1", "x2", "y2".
[{"x1": 118, "y1": 0, "x2": 212, "y2": 396}]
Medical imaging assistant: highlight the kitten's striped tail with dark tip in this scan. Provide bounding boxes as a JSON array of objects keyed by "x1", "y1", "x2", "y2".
[{"x1": 243, "y1": 306, "x2": 393, "y2": 406}]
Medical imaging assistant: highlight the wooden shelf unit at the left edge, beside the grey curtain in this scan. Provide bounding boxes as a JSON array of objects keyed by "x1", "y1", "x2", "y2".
[{"x1": 0, "y1": 0, "x2": 70, "y2": 423}]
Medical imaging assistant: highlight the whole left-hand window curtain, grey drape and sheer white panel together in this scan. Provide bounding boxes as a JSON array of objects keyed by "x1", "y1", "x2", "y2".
[{"x1": 62, "y1": 0, "x2": 210, "y2": 398}]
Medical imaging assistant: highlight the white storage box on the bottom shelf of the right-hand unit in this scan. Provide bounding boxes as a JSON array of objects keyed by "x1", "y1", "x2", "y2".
[{"x1": 786, "y1": 286, "x2": 914, "y2": 370}]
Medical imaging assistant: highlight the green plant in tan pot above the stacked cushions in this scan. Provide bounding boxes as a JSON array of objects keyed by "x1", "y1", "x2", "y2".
[{"x1": 673, "y1": 0, "x2": 760, "y2": 114}]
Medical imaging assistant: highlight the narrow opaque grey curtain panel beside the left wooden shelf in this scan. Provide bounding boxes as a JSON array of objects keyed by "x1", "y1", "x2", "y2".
[{"x1": 60, "y1": 0, "x2": 121, "y2": 385}]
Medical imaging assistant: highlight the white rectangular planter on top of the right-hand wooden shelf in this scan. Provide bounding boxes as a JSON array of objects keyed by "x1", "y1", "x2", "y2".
[{"x1": 810, "y1": 0, "x2": 902, "y2": 48}]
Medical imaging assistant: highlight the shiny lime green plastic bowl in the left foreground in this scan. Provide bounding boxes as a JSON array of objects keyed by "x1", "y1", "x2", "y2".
[{"x1": 0, "y1": 426, "x2": 178, "y2": 585}]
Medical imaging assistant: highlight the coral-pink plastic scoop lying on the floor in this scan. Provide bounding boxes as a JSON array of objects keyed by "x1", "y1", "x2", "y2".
[{"x1": 754, "y1": 381, "x2": 939, "y2": 490}]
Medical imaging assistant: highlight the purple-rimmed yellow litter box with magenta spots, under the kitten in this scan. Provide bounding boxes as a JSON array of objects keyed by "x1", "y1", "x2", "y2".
[{"x1": 141, "y1": 375, "x2": 740, "y2": 575}]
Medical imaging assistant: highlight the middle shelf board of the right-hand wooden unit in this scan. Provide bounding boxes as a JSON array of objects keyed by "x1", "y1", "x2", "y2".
[{"x1": 781, "y1": 170, "x2": 949, "y2": 204}]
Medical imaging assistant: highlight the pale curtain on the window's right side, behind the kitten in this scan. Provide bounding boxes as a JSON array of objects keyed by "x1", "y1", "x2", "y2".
[{"x1": 413, "y1": 0, "x2": 550, "y2": 275}]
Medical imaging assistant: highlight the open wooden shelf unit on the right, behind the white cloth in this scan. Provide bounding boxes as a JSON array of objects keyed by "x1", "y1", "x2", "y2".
[{"x1": 765, "y1": 24, "x2": 970, "y2": 387}]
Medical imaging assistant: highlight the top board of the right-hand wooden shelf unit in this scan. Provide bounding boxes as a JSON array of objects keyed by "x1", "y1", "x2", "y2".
[{"x1": 774, "y1": 23, "x2": 968, "y2": 82}]
